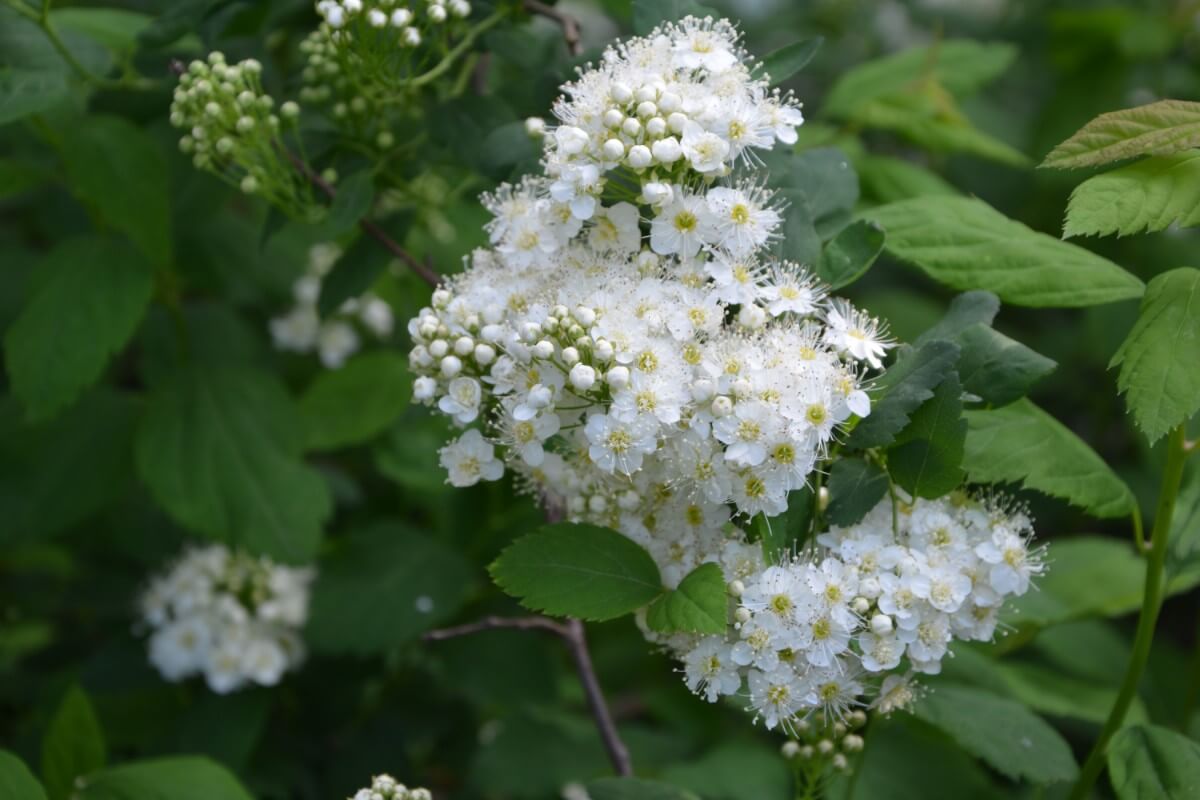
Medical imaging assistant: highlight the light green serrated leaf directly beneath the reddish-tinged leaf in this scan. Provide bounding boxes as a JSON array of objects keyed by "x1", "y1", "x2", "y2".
[{"x1": 1062, "y1": 150, "x2": 1200, "y2": 237}]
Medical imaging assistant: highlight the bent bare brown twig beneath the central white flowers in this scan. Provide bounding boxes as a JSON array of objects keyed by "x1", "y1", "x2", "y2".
[{"x1": 421, "y1": 616, "x2": 634, "y2": 777}]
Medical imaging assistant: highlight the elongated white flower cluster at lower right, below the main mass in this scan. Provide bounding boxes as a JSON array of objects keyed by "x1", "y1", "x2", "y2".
[{"x1": 666, "y1": 493, "x2": 1043, "y2": 735}]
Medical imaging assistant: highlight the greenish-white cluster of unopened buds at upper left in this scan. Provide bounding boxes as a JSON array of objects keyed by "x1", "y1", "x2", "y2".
[{"x1": 170, "y1": 52, "x2": 311, "y2": 215}]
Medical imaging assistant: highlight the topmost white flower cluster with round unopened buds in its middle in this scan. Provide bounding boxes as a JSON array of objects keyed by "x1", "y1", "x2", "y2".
[{"x1": 545, "y1": 17, "x2": 804, "y2": 221}]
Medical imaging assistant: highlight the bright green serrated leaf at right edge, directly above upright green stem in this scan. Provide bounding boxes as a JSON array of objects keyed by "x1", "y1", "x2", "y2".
[{"x1": 1109, "y1": 266, "x2": 1200, "y2": 443}]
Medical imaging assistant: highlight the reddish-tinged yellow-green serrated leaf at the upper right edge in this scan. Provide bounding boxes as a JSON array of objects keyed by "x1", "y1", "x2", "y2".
[{"x1": 1040, "y1": 100, "x2": 1200, "y2": 169}]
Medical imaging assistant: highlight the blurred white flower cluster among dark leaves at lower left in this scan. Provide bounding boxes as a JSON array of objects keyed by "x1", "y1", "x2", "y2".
[{"x1": 140, "y1": 545, "x2": 313, "y2": 694}]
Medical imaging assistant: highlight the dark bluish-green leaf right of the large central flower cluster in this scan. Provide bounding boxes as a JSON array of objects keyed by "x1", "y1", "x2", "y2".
[{"x1": 954, "y1": 324, "x2": 1058, "y2": 408}]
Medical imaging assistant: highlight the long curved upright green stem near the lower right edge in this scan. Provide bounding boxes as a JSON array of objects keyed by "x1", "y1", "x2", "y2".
[{"x1": 1070, "y1": 425, "x2": 1187, "y2": 800}]
